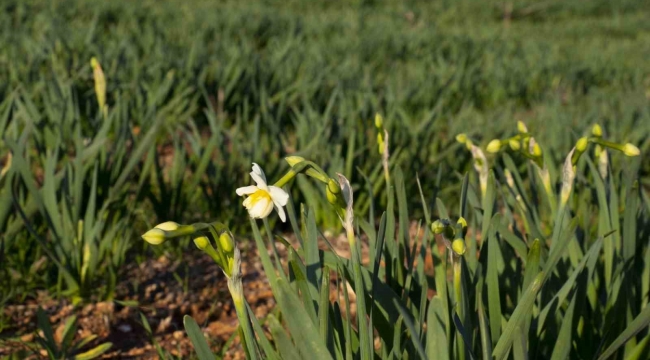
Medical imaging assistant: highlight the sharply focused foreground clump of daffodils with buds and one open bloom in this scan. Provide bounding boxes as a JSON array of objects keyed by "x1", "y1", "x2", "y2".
[{"x1": 142, "y1": 115, "x2": 650, "y2": 360}]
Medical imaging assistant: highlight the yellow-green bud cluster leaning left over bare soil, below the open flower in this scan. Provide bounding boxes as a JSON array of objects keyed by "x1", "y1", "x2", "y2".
[{"x1": 142, "y1": 221, "x2": 241, "y2": 281}]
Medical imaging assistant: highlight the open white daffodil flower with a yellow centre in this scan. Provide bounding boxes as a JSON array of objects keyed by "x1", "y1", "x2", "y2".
[{"x1": 236, "y1": 163, "x2": 289, "y2": 222}]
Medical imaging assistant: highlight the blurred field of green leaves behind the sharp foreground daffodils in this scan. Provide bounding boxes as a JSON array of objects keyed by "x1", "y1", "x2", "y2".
[{"x1": 0, "y1": 0, "x2": 650, "y2": 312}]
